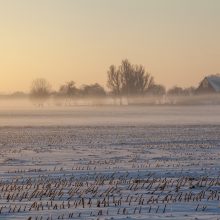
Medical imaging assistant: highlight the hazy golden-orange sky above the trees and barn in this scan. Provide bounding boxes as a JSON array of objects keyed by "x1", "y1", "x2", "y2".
[{"x1": 0, "y1": 0, "x2": 220, "y2": 92}]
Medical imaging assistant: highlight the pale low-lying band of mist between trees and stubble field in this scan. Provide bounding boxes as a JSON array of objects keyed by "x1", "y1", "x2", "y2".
[{"x1": 0, "y1": 98, "x2": 220, "y2": 126}]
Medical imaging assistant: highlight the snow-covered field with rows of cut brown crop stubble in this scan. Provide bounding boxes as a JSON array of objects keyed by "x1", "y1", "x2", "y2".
[{"x1": 0, "y1": 106, "x2": 220, "y2": 220}]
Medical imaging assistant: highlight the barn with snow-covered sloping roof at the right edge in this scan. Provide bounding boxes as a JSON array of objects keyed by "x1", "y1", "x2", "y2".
[{"x1": 197, "y1": 74, "x2": 220, "y2": 93}]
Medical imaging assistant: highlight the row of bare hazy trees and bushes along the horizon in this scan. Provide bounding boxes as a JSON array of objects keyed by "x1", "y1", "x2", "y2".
[{"x1": 30, "y1": 59, "x2": 195, "y2": 98}]
